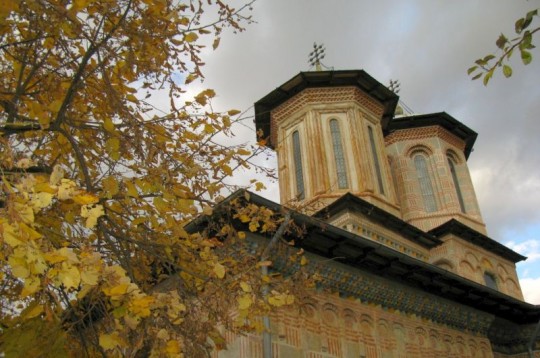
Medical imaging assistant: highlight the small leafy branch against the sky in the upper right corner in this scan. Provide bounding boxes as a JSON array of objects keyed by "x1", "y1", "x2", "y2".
[{"x1": 467, "y1": 9, "x2": 540, "y2": 85}]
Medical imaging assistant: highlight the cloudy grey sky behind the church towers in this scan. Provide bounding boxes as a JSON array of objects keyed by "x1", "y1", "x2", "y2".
[{"x1": 178, "y1": 0, "x2": 540, "y2": 304}]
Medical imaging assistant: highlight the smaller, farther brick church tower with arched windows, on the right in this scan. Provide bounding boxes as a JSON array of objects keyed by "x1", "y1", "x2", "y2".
[{"x1": 385, "y1": 112, "x2": 486, "y2": 234}]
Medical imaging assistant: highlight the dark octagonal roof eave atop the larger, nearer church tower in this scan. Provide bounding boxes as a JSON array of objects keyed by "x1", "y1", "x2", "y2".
[{"x1": 255, "y1": 70, "x2": 399, "y2": 148}]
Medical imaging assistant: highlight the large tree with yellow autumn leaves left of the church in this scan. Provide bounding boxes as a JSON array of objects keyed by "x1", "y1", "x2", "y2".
[{"x1": 0, "y1": 0, "x2": 308, "y2": 357}]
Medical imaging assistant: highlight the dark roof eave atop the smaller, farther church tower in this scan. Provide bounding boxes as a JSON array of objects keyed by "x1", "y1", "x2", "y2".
[{"x1": 383, "y1": 112, "x2": 478, "y2": 158}]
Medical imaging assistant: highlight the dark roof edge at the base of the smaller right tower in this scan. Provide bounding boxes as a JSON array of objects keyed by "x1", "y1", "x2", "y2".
[{"x1": 429, "y1": 219, "x2": 527, "y2": 263}]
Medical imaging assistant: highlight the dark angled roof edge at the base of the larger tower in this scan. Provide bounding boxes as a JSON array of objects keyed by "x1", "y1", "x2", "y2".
[{"x1": 314, "y1": 193, "x2": 442, "y2": 249}]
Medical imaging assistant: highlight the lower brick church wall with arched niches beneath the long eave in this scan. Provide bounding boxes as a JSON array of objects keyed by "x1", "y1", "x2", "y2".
[{"x1": 214, "y1": 294, "x2": 498, "y2": 358}]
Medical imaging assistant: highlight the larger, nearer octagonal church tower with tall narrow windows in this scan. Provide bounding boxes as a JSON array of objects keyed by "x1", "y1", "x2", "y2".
[{"x1": 255, "y1": 70, "x2": 400, "y2": 216}]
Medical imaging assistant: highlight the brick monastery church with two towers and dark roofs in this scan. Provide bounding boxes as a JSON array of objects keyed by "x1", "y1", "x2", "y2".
[{"x1": 213, "y1": 65, "x2": 540, "y2": 358}]
